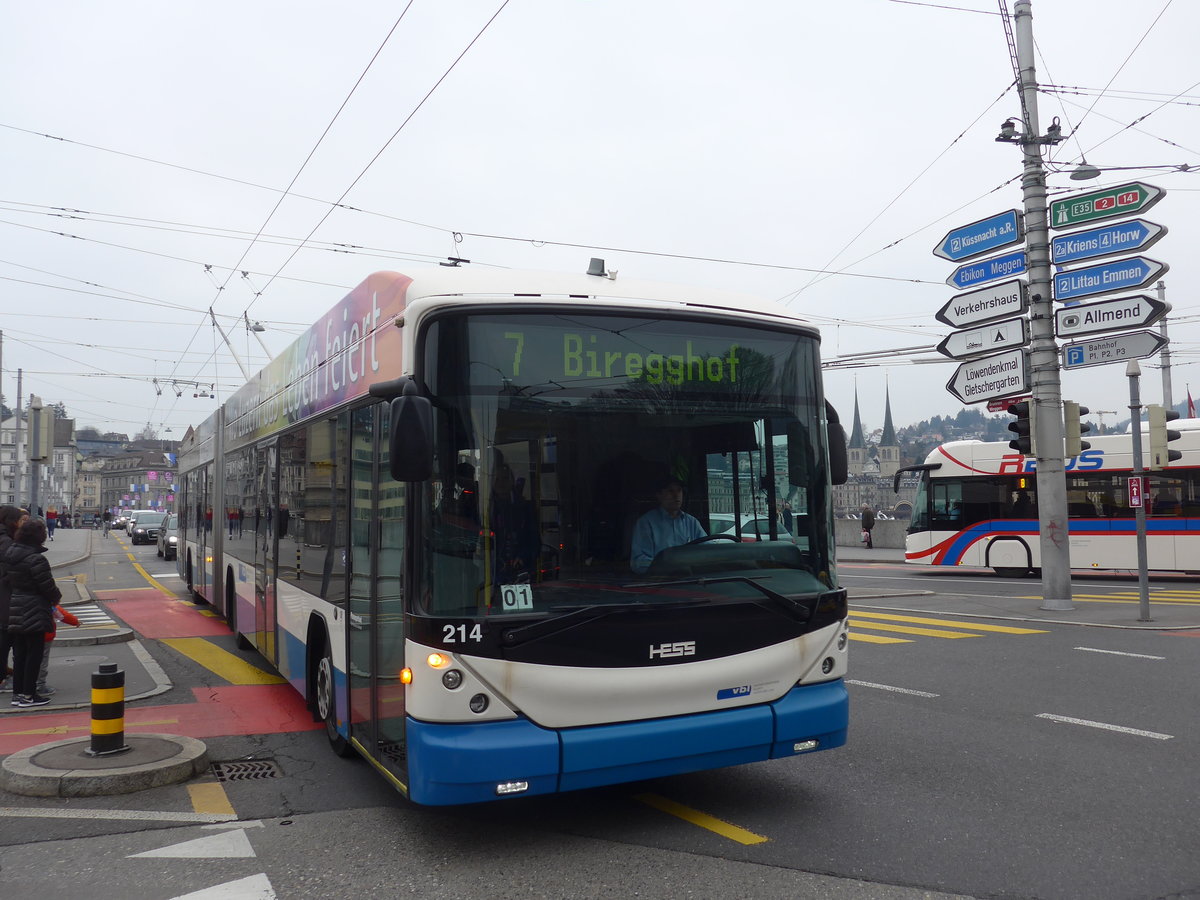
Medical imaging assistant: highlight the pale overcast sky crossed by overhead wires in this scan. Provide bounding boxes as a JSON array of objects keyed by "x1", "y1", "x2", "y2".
[{"x1": 0, "y1": 0, "x2": 1200, "y2": 439}]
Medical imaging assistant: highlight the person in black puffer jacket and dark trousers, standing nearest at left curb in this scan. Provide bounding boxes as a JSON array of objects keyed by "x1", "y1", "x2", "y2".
[{"x1": 4, "y1": 518, "x2": 62, "y2": 708}]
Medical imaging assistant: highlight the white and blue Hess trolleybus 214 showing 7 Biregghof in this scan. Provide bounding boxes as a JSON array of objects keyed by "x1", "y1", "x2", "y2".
[{"x1": 179, "y1": 260, "x2": 848, "y2": 804}]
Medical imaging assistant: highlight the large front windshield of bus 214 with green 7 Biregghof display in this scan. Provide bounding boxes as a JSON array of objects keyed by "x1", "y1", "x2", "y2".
[{"x1": 416, "y1": 308, "x2": 836, "y2": 617}]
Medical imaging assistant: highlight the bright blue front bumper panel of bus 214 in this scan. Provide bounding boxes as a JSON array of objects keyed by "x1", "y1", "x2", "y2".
[{"x1": 407, "y1": 680, "x2": 850, "y2": 805}]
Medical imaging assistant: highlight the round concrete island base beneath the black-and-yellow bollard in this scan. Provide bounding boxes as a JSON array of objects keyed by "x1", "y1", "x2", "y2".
[{"x1": 0, "y1": 734, "x2": 209, "y2": 797}]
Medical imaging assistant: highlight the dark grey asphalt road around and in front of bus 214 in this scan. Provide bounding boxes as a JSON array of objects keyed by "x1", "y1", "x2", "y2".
[{"x1": 0, "y1": 547, "x2": 1200, "y2": 900}]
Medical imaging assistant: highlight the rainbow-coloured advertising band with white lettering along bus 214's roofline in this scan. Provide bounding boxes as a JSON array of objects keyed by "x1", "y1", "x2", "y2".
[{"x1": 226, "y1": 272, "x2": 413, "y2": 448}]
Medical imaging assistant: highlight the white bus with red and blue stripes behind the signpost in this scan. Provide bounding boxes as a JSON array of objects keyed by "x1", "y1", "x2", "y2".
[{"x1": 896, "y1": 419, "x2": 1200, "y2": 577}]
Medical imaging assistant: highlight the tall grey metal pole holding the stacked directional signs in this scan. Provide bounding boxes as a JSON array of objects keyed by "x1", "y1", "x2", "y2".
[{"x1": 1013, "y1": 0, "x2": 1075, "y2": 610}]
